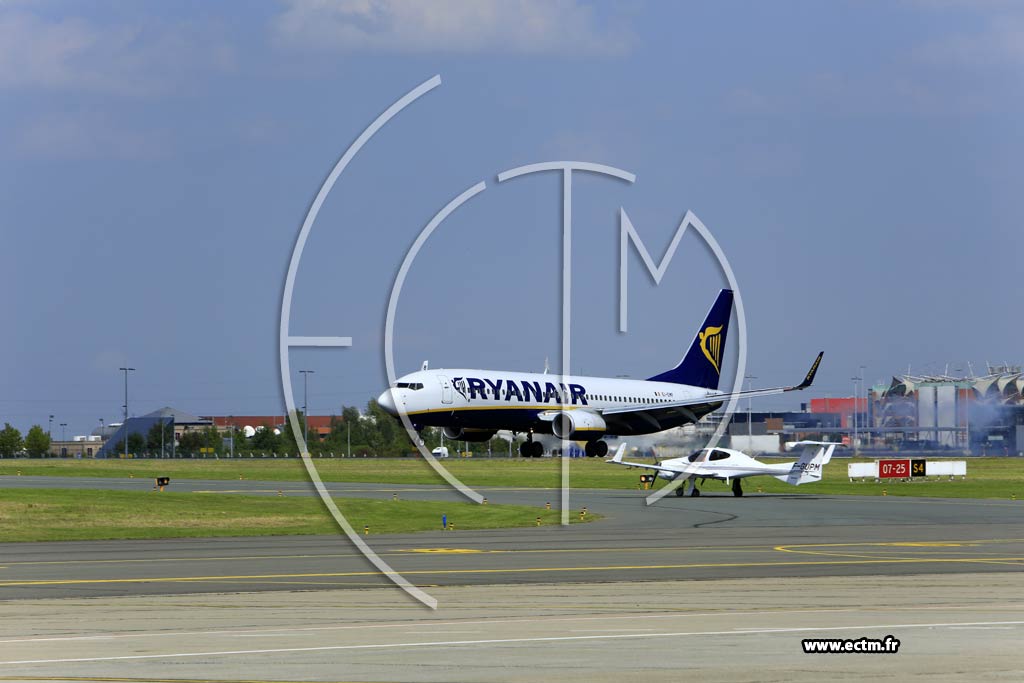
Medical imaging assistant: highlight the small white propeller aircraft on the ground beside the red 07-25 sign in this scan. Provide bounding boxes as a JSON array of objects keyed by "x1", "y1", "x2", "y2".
[{"x1": 605, "y1": 441, "x2": 839, "y2": 497}]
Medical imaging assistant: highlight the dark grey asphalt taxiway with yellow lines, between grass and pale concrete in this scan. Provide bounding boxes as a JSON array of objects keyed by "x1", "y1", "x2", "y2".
[{"x1": 0, "y1": 477, "x2": 1024, "y2": 600}]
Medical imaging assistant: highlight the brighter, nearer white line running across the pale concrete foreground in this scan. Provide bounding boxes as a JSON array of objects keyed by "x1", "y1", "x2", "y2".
[{"x1": 0, "y1": 622, "x2": 1024, "y2": 666}]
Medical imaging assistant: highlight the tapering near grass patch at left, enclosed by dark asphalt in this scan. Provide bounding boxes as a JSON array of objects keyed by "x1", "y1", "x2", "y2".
[{"x1": 0, "y1": 488, "x2": 599, "y2": 541}]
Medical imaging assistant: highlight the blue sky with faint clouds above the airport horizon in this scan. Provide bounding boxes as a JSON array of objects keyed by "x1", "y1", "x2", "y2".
[{"x1": 0, "y1": 0, "x2": 1024, "y2": 434}]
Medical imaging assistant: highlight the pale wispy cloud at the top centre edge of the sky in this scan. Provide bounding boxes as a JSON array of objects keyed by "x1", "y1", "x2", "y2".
[{"x1": 273, "y1": 0, "x2": 632, "y2": 54}]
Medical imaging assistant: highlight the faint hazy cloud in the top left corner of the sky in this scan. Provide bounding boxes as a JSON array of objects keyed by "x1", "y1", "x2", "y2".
[{"x1": 0, "y1": 10, "x2": 234, "y2": 95}]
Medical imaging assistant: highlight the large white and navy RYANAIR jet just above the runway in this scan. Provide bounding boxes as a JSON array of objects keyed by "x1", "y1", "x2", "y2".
[{"x1": 377, "y1": 290, "x2": 823, "y2": 458}]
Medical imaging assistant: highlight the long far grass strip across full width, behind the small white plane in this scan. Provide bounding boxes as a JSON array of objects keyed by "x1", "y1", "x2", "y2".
[{"x1": 0, "y1": 458, "x2": 1024, "y2": 501}]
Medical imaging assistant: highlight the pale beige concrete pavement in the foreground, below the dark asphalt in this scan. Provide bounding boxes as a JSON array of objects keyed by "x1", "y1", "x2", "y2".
[{"x1": 0, "y1": 573, "x2": 1024, "y2": 683}]
